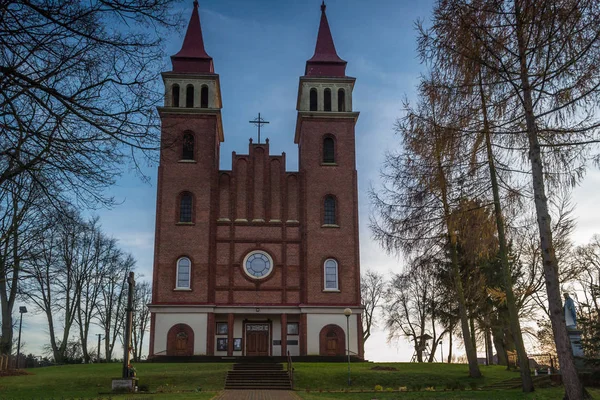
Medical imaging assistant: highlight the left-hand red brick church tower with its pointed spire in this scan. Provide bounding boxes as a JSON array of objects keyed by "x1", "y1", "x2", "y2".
[{"x1": 150, "y1": 1, "x2": 224, "y2": 355}]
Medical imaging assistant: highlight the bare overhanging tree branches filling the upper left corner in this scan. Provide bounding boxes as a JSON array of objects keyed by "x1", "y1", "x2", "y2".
[{"x1": 0, "y1": 0, "x2": 175, "y2": 206}]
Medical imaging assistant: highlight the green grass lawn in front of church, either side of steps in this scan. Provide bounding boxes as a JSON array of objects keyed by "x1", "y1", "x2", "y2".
[{"x1": 0, "y1": 363, "x2": 600, "y2": 400}]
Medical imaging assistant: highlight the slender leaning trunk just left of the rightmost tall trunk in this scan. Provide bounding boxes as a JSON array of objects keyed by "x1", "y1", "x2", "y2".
[{"x1": 479, "y1": 75, "x2": 534, "y2": 393}]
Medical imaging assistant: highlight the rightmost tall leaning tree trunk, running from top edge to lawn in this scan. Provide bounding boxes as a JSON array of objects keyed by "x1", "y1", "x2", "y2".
[{"x1": 514, "y1": 1, "x2": 589, "y2": 400}]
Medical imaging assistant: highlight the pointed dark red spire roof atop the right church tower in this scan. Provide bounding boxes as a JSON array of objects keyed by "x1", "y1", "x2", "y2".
[{"x1": 304, "y1": 1, "x2": 347, "y2": 76}]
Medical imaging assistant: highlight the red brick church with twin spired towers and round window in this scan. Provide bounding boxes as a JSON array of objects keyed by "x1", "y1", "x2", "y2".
[{"x1": 149, "y1": 1, "x2": 363, "y2": 359}]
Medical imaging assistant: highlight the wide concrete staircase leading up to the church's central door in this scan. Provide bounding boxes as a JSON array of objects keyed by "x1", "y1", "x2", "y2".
[{"x1": 225, "y1": 363, "x2": 292, "y2": 390}]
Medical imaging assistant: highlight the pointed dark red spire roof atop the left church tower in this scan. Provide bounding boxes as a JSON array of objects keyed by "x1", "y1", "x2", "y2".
[{"x1": 171, "y1": 0, "x2": 214, "y2": 74}]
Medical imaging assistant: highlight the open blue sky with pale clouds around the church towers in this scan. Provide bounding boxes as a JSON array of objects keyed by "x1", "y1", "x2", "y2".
[{"x1": 17, "y1": 0, "x2": 600, "y2": 361}]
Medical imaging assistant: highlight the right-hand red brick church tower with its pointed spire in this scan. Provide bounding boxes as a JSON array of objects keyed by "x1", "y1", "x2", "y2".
[{"x1": 294, "y1": 2, "x2": 362, "y2": 355}]
